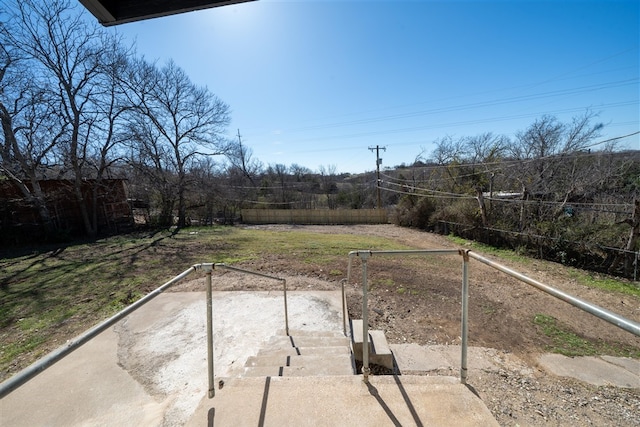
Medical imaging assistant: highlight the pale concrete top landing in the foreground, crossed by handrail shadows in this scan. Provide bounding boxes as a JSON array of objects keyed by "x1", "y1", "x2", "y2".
[{"x1": 185, "y1": 375, "x2": 498, "y2": 427}]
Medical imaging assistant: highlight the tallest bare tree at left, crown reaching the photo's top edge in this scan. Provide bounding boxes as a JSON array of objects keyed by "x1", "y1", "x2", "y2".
[{"x1": 5, "y1": 0, "x2": 132, "y2": 237}]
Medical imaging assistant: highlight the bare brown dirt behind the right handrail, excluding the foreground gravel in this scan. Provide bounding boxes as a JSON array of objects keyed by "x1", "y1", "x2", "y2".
[{"x1": 241, "y1": 225, "x2": 640, "y2": 363}]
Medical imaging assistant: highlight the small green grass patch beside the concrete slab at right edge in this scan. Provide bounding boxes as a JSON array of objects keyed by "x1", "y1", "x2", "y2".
[{"x1": 533, "y1": 314, "x2": 640, "y2": 358}]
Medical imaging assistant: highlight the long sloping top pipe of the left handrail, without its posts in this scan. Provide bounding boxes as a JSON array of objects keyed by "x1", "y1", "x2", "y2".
[{"x1": 0, "y1": 264, "x2": 201, "y2": 399}]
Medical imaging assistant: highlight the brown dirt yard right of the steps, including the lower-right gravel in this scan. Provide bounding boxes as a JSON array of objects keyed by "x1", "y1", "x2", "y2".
[{"x1": 176, "y1": 225, "x2": 640, "y2": 426}]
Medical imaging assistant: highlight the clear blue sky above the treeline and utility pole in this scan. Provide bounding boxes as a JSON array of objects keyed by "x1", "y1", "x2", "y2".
[{"x1": 109, "y1": 0, "x2": 640, "y2": 173}]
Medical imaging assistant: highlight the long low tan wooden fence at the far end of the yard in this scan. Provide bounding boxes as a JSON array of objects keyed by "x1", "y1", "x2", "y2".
[{"x1": 242, "y1": 209, "x2": 388, "y2": 224}]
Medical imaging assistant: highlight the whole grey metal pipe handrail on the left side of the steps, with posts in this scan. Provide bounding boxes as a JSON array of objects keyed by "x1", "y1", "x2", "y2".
[{"x1": 0, "y1": 263, "x2": 289, "y2": 399}]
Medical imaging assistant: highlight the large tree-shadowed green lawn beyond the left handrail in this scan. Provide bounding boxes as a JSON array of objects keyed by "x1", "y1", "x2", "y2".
[{"x1": 0, "y1": 227, "x2": 406, "y2": 380}]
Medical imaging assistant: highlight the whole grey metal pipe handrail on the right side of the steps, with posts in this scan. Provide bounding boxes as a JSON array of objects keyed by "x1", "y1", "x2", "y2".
[{"x1": 342, "y1": 249, "x2": 640, "y2": 384}]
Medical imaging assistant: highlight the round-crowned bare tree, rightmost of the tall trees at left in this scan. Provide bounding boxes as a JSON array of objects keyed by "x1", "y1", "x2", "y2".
[{"x1": 129, "y1": 60, "x2": 230, "y2": 227}]
